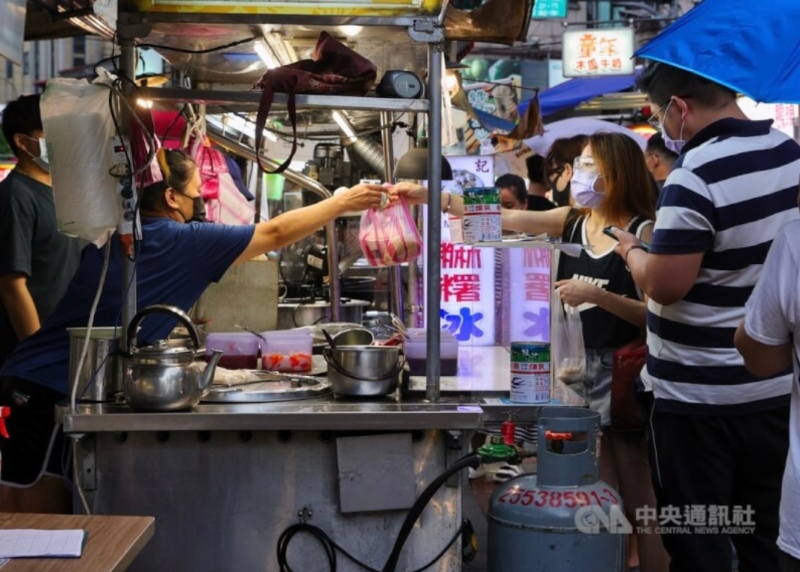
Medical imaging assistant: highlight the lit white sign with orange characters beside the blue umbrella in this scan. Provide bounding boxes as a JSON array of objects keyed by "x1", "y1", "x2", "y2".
[{"x1": 563, "y1": 28, "x2": 635, "y2": 77}]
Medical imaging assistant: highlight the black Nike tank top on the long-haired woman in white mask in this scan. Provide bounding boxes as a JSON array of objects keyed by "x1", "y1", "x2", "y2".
[{"x1": 558, "y1": 216, "x2": 649, "y2": 349}]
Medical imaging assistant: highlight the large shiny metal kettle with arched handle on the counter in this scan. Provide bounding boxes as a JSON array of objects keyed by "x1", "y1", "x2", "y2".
[{"x1": 122, "y1": 304, "x2": 222, "y2": 412}]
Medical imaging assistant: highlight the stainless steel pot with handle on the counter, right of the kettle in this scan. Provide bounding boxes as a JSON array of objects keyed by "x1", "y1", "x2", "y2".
[{"x1": 322, "y1": 346, "x2": 405, "y2": 396}]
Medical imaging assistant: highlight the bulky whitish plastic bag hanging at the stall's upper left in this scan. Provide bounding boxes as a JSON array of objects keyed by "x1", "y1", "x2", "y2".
[{"x1": 40, "y1": 69, "x2": 122, "y2": 247}]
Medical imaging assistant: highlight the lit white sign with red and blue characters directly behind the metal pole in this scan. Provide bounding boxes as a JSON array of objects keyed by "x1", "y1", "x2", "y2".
[{"x1": 424, "y1": 157, "x2": 496, "y2": 346}]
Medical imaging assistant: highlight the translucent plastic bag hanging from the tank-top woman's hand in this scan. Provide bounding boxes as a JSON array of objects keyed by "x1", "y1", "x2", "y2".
[{"x1": 550, "y1": 290, "x2": 586, "y2": 384}]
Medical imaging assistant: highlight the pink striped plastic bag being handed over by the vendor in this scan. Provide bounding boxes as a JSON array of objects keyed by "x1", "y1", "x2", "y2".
[{"x1": 358, "y1": 199, "x2": 422, "y2": 266}]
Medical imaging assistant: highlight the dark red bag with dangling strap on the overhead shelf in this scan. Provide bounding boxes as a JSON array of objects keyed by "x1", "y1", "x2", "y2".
[{"x1": 254, "y1": 32, "x2": 378, "y2": 173}]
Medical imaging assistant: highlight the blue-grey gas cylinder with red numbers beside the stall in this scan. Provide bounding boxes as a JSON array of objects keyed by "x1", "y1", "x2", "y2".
[{"x1": 488, "y1": 407, "x2": 631, "y2": 572}]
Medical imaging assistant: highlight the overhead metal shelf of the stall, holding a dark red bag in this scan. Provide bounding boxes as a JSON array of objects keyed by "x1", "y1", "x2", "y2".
[{"x1": 136, "y1": 87, "x2": 430, "y2": 113}]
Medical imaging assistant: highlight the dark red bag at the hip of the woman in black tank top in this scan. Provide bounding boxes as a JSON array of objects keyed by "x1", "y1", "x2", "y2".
[{"x1": 611, "y1": 339, "x2": 647, "y2": 431}]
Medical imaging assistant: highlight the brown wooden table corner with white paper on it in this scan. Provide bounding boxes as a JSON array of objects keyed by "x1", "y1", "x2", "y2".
[{"x1": 0, "y1": 513, "x2": 155, "y2": 572}]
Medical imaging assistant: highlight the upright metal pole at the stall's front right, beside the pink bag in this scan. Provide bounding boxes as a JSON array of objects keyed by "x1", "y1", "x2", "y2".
[{"x1": 425, "y1": 44, "x2": 444, "y2": 401}]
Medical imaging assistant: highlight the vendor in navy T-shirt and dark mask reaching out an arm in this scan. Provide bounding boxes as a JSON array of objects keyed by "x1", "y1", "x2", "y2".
[{"x1": 0, "y1": 151, "x2": 383, "y2": 513}]
